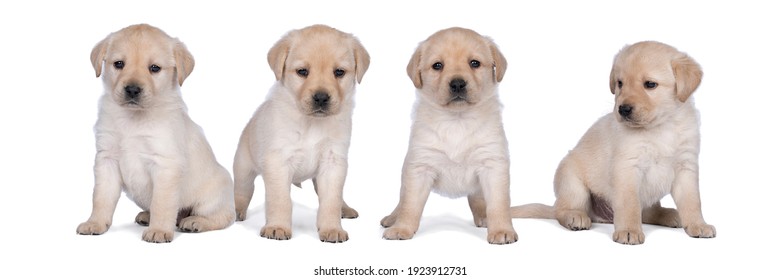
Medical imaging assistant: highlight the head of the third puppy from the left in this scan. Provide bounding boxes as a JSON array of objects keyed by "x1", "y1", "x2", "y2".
[{"x1": 407, "y1": 27, "x2": 507, "y2": 110}]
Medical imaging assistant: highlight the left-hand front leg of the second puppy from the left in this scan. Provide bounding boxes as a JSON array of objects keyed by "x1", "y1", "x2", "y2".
[{"x1": 260, "y1": 161, "x2": 293, "y2": 240}]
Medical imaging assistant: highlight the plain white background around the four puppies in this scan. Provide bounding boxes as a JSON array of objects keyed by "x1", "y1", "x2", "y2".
[{"x1": 0, "y1": 0, "x2": 781, "y2": 279}]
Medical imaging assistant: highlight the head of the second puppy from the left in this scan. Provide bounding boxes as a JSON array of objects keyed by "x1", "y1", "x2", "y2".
[{"x1": 268, "y1": 25, "x2": 369, "y2": 117}]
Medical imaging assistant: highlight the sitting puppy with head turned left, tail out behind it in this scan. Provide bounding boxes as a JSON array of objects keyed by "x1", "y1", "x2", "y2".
[{"x1": 512, "y1": 42, "x2": 716, "y2": 244}]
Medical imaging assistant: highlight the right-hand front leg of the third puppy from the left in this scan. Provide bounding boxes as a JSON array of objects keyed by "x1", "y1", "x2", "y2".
[{"x1": 478, "y1": 164, "x2": 518, "y2": 244}]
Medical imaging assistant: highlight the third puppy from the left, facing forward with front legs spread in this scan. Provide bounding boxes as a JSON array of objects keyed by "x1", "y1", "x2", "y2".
[{"x1": 380, "y1": 28, "x2": 518, "y2": 244}]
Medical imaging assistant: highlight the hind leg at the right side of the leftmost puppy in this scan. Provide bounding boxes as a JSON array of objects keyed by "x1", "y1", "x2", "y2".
[{"x1": 177, "y1": 173, "x2": 236, "y2": 232}]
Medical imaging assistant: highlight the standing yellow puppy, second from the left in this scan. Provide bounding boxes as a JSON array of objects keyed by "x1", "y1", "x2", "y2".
[{"x1": 233, "y1": 25, "x2": 369, "y2": 242}]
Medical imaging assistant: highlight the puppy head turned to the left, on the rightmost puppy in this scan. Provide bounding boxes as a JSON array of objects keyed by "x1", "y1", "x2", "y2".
[{"x1": 610, "y1": 41, "x2": 702, "y2": 127}]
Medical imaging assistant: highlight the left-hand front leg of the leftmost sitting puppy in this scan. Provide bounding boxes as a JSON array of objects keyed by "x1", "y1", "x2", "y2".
[{"x1": 76, "y1": 158, "x2": 122, "y2": 235}]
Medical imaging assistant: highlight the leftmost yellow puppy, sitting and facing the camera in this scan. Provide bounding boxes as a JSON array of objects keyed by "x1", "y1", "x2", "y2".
[{"x1": 76, "y1": 24, "x2": 235, "y2": 243}]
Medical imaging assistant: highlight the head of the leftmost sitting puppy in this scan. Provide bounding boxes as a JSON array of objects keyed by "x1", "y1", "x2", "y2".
[{"x1": 90, "y1": 24, "x2": 195, "y2": 109}]
